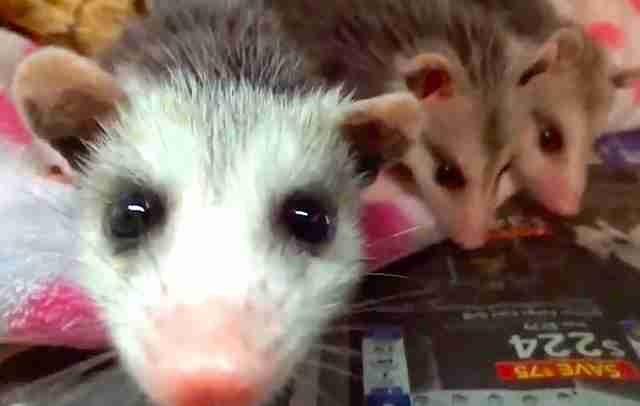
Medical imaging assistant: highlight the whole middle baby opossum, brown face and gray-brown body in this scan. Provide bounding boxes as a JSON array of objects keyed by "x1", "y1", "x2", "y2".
[{"x1": 270, "y1": 0, "x2": 529, "y2": 248}]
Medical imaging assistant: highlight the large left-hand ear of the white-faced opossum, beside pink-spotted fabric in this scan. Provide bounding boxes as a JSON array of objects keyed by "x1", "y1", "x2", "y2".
[{"x1": 12, "y1": 46, "x2": 125, "y2": 166}]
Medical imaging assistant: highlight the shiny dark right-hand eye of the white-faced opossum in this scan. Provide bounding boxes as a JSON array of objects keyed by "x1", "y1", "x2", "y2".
[{"x1": 279, "y1": 193, "x2": 336, "y2": 249}]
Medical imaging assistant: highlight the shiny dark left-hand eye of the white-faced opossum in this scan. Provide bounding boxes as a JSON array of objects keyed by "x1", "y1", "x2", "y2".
[{"x1": 107, "y1": 190, "x2": 165, "y2": 247}]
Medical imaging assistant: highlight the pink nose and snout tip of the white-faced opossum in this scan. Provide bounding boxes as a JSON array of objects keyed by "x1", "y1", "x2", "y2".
[{"x1": 142, "y1": 303, "x2": 275, "y2": 406}]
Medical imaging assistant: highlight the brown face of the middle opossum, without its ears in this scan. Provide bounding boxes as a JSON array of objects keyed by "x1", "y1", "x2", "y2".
[{"x1": 406, "y1": 96, "x2": 513, "y2": 248}]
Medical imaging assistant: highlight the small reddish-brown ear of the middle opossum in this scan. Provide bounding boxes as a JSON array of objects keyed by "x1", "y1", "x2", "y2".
[{"x1": 397, "y1": 53, "x2": 457, "y2": 100}]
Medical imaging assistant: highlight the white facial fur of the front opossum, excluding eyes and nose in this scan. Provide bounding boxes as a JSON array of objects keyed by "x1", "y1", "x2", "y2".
[{"x1": 70, "y1": 71, "x2": 362, "y2": 404}]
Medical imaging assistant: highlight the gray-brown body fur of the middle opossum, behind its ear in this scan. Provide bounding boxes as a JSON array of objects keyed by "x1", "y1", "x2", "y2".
[{"x1": 269, "y1": 0, "x2": 510, "y2": 98}]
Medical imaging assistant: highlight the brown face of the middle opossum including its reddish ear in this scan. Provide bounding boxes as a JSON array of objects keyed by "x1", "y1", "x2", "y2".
[{"x1": 390, "y1": 54, "x2": 518, "y2": 248}]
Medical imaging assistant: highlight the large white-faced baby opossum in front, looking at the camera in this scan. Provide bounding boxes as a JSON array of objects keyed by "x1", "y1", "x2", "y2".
[{"x1": 12, "y1": 0, "x2": 416, "y2": 406}]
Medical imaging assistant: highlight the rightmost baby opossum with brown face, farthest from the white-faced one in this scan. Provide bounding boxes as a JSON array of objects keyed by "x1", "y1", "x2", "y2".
[{"x1": 476, "y1": 0, "x2": 640, "y2": 215}]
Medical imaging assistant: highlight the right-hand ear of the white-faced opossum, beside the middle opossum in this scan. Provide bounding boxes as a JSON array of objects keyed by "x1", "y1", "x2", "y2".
[{"x1": 341, "y1": 92, "x2": 425, "y2": 181}]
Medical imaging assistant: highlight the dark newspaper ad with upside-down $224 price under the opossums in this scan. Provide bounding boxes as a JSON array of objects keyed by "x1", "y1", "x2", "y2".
[{"x1": 351, "y1": 165, "x2": 640, "y2": 406}]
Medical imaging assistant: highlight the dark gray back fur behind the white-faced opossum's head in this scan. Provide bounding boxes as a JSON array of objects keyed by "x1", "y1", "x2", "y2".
[{"x1": 98, "y1": 0, "x2": 328, "y2": 97}]
